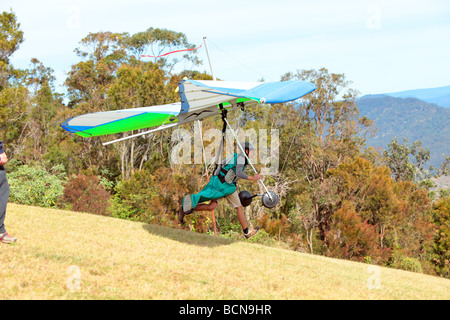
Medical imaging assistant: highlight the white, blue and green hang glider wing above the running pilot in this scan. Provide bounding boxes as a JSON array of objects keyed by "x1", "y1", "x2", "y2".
[{"x1": 61, "y1": 80, "x2": 315, "y2": 141}]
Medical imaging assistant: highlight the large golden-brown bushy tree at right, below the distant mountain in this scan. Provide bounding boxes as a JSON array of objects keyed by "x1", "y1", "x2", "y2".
[{"x1": 327, "y1": 157, "x2": 434, "y2": 267}]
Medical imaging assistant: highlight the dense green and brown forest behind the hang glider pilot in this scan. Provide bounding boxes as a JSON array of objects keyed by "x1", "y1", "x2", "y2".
[{"x1": 0, "y1": 11, "x2": 450, "y2": 278}]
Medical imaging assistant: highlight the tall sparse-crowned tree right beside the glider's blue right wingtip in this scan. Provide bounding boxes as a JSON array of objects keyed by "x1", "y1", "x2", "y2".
[{"x1": 280, "y1": 68, "x2": 370, "y2": 244}]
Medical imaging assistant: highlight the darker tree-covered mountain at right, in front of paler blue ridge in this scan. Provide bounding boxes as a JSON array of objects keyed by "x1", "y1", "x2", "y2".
[{"x1": 357, "y1": 95, "x2": 450, "y2": 168}]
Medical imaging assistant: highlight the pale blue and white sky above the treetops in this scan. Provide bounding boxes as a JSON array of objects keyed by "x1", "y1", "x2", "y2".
[{"x1": 0, "y1": 0, "x2": 450, "y2": 95}]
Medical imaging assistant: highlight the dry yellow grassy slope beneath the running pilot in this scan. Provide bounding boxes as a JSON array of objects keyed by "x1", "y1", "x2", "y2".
[{"x1": 0, "y1": 204, "x2": 450, "y2": 300}]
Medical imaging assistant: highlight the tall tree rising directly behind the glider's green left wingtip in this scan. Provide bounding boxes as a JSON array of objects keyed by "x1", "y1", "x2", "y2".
[{"x1": 65, "y1": 32, "x2": 127, "y2": 174}]
